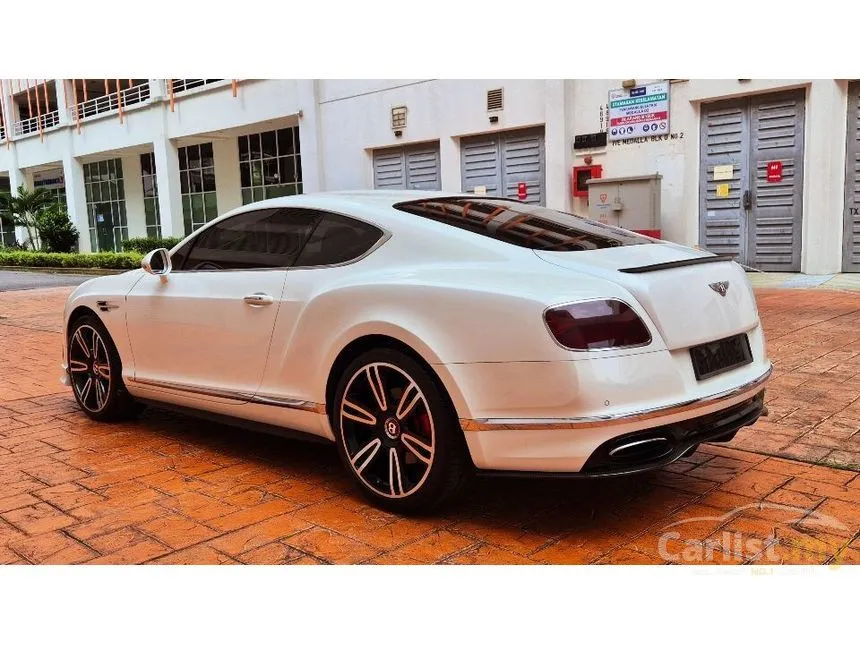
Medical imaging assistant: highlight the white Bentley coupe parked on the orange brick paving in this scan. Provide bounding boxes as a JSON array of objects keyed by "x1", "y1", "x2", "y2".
[{"x1": 63, "y1": 191, "x2": 771, "y2": 512}]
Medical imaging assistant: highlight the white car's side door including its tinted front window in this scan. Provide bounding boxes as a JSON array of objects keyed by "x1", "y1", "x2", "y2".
[{"x1": 127, "y1": 208, "x2": 318, "y2": 404}]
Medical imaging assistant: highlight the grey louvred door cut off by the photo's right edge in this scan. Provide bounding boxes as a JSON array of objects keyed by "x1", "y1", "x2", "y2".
[{"x1": 842, "y1": 81, "x2": 860, "y2": 273}]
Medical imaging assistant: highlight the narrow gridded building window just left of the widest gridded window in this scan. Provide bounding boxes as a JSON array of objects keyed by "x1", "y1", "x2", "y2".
[{"x1": 179, "y1": 143, "x2": 218, "y2": 235}]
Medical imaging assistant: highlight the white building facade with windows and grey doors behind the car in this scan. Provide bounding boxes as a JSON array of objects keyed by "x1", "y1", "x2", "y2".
[{"x1": 0, "y1": 79, "x2": 860, "y2": 274}]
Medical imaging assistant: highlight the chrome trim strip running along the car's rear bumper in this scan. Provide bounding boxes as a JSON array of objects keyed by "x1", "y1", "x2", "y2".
[{"x1": 460, "y1": 365, "x2": 773, "y2": 432}]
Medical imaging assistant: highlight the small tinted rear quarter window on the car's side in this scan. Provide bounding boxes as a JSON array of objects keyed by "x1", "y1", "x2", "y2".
[{"x1": 295, "y1": 213, "x2": 382, "y2": 267}]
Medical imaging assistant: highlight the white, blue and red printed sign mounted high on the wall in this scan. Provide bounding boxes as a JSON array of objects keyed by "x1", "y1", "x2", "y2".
[{"x1": 609, "y1": 81, "x2": 669, "y2": 141}]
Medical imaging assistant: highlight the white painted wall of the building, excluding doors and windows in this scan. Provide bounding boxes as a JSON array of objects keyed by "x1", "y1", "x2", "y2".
[{"x1": 0, "y1": 78, "x2": 847, "y2": 273}]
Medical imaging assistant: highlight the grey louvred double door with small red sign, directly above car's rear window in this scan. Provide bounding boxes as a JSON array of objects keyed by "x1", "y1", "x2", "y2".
[{"x1": 460, "y1": 128, "x2": 546, "y2": 206}]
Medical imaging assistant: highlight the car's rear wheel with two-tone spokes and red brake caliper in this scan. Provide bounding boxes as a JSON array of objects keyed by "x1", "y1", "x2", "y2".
[{"x1": 329, "y1": 349, "x2": 472, "y2": 513}]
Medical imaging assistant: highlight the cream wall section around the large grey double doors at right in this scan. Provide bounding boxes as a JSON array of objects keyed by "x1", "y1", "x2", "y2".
[{"x1": 573, "y1": 79, "x2": 847, "y2": 273}]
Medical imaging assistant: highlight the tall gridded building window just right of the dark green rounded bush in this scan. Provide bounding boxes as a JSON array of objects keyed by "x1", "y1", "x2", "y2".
[{"x1": 84, "y1": 159, "x2": 128, "y2": 251}]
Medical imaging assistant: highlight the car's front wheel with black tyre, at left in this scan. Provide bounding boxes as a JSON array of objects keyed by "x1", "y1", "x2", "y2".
[{"x1": 66, "y1": 315, "x2": 143, "y2": 421}]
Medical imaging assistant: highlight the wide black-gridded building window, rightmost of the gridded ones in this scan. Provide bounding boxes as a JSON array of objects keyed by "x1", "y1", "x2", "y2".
[{"x1": 239, "y1": 127, "x2": 302, "y2": 204}]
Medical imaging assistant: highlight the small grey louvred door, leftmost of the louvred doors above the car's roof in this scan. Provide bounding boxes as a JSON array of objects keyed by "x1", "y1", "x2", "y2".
[{"x1": 373, "y1": 143, "x2": 442, "y2": 190}]
